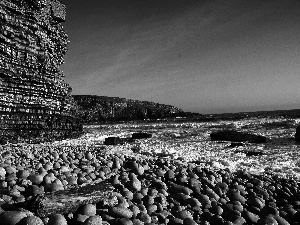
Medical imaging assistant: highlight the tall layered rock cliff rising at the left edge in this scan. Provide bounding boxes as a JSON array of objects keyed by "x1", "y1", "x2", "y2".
[{"x1": 0, "y1": 0, "x2": 82, "y2": 143}]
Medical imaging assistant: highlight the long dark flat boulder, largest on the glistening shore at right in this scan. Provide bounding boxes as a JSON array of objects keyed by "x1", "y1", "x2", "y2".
[{"x1": 210, "y1": 130, "x2": 267, "y2": 143}]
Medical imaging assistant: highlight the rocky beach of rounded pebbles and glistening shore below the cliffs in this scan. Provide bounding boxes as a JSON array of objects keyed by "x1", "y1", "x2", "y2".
[{"x1": 0, "y1": 118, "x2": 300, "y2": 225}]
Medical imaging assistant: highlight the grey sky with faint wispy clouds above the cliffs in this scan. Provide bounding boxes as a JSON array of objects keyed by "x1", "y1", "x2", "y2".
[{"x1": 61, "y1": 0, "x2": 300, "y2": 114}]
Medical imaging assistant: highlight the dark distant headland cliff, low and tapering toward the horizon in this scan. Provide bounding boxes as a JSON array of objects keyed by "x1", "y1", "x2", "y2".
[{"x1": 73, "y1": 95, "x2": 185, "y2": 123}]
